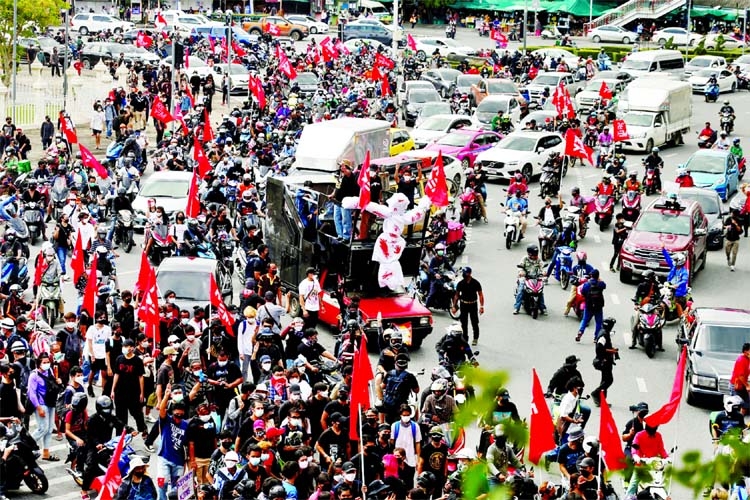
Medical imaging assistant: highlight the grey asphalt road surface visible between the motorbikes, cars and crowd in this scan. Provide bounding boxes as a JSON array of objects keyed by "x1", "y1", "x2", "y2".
[{"x1": 13, "y1": 24, "x2": 750, "y2": 500}]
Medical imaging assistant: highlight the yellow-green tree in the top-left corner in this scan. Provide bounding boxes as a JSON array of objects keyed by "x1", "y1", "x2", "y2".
[{"x1": 0, "y1": 0, "x2": 70, "y2": 85}]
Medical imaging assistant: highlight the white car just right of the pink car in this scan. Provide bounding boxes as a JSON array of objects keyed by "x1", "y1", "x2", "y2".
[{"x1": 474, "y1": 130, "x2": 566, "y2": 179}]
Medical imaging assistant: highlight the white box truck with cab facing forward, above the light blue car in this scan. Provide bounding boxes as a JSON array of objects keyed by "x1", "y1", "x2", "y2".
[{"x1": 618, "y1": 77, "x2": 693, "y2": 152}]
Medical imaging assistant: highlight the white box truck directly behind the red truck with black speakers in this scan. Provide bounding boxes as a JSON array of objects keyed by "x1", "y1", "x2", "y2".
[{"x1": 292, "y1": 118, "x2": 391, "y2": 172}]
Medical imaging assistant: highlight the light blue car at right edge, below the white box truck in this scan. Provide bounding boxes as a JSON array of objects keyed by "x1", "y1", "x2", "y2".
[{"x1": 683, "y1": 149, "x2": 740, "y2": 202}]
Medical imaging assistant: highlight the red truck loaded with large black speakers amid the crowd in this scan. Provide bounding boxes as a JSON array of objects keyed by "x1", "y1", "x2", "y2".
[{"x1": 263, "y1": 176, "x2": 432, "y2": 349}]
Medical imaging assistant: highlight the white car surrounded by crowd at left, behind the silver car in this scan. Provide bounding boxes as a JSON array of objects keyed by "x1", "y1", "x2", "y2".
[{"x1": 133, "y1": 170, "x2": 193, "y2": 229}]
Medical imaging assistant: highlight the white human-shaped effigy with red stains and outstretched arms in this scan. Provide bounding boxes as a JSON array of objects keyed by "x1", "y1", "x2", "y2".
[{"x1": 341, "y1": 193, "x2": 431, "y2": 290}]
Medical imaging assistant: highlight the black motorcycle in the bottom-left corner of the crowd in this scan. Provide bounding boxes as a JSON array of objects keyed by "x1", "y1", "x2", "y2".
[{"x1": 3, "y1": 424, "x2": 49, "y2": 495}]
